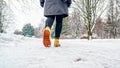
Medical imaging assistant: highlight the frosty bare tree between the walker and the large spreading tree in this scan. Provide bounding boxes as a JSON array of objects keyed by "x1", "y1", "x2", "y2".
[{"x1": 68, "y1": 10, "x2": 86, "y2": 38}]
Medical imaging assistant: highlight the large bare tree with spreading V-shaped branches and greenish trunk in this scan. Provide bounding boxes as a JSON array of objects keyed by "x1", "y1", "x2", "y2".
[{"x1": 73, "y1": 0, "x2": 107, "y2": 39}]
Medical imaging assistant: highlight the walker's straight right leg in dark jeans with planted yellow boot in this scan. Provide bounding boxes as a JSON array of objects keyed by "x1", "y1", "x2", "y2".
[{"x1": 54, "y1": 15, "x2": 63, "y2": 47}]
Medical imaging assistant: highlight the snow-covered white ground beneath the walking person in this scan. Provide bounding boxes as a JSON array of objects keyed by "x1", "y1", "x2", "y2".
[{"x1": 0, "y1": 34, "x2": 120, "y2": 68}]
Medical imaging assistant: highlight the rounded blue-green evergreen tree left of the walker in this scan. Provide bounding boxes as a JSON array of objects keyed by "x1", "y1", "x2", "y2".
[{"x1": 22, "y1": 24, "x2": 34, "y2": 37}]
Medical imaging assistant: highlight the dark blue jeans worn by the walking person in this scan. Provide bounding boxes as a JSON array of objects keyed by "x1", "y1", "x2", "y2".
[{"x1": 45, "y1": 15, "x2": 63, "y2": 39}]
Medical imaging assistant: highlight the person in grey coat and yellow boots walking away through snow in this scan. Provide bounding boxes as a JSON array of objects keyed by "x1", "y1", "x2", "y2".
[{"x1": 40, "y1": 0, "x2": 72, "y2": 47}]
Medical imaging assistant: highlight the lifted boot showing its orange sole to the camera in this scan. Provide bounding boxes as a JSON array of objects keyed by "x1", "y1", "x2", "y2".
[{"x1": 43, "y1": 27, "x2": 51, "y2": 47}]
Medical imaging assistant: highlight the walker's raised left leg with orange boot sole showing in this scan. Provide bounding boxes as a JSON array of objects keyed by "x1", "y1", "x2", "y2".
[{"x1": 43, "y1": 16, "x2": 55, "y2": 47}]
